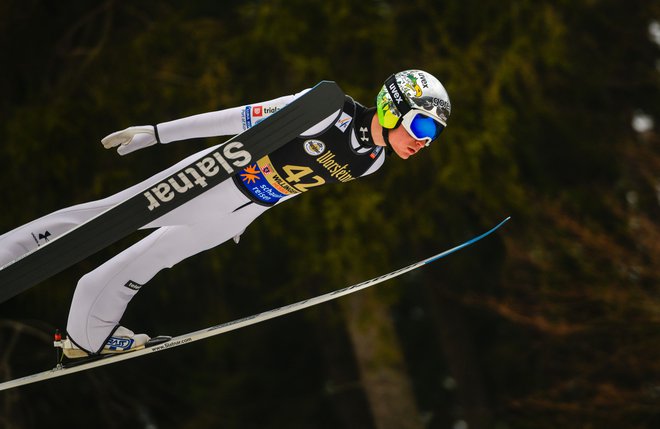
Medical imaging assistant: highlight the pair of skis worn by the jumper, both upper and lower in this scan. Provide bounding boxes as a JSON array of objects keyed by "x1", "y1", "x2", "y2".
[{"x1": 0, "y1": 81, "x2": 508, "y2": 390}]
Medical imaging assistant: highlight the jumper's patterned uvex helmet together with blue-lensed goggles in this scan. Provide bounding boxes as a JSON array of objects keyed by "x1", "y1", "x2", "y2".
[{"x1": 376, "y1": 70, "x2": 451, "y2": 146}]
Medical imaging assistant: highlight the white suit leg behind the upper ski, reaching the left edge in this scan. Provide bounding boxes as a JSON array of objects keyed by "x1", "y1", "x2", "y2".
[{"x1": 0, "y1": 147, "x2": 222, "y2": 267}]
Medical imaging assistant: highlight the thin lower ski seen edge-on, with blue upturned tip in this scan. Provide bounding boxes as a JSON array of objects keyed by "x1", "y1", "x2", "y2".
[{"x1": 0, "y1": 217, "x2": 510, "y2": 391}]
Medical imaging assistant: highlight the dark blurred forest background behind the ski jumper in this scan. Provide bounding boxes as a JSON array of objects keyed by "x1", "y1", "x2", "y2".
[{"x1": 0, "y1": 0, "x2": 660, "y2": 429}]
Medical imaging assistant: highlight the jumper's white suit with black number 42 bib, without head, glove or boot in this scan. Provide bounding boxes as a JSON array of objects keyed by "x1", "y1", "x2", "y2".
[{"x1": 0, "y1": 91, "x2": 385, "y2": 353}]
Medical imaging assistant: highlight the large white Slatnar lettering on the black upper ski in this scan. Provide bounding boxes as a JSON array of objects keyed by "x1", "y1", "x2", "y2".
[{"x1": 143, "y1": 142, "x2": 252, "y2": 211}]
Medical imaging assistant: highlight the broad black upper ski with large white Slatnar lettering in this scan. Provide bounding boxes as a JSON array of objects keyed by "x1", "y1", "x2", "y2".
[{"x1": 0, "y1": 81, "x2": 344, "y2": 302}]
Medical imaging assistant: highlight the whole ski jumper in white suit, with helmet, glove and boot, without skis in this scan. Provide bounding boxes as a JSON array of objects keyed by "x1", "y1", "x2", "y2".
[{"x1": 0, "y1": 70, "x2": 451, "y2": 358}]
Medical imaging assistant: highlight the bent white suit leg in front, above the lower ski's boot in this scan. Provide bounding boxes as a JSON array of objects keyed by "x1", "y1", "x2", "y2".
[{"x1": 67, "y1": 180, "x2": 268, "y2": 352}]
